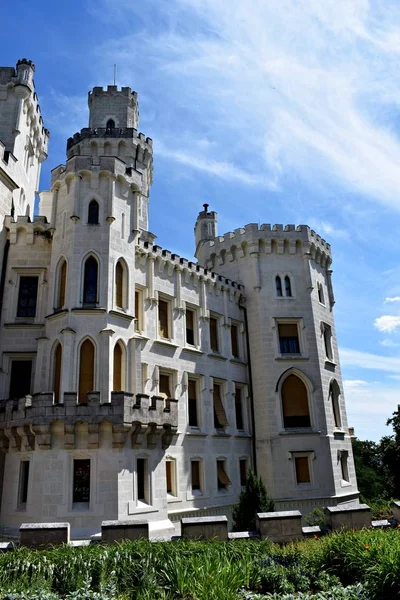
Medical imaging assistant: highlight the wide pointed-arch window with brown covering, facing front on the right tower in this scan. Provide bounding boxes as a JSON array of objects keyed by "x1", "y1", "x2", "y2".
[{"x1": 281, "y1": 375, "x2": 311, "y2": 429}]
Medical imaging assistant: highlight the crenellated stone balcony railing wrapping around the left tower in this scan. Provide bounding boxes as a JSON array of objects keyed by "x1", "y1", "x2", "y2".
[{"x1": 0, "y1": 392, "x2": 178, "y2": 450}]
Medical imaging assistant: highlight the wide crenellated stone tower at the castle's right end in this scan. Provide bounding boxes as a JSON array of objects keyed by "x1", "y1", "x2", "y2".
[{"x1": 195, "y1": 218, "x2": 358, "y2": 510}]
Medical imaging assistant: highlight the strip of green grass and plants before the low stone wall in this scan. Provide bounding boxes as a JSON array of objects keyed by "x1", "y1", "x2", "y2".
[{"x1": 0, "y1": 529, "x2": 400, "y2": 600}]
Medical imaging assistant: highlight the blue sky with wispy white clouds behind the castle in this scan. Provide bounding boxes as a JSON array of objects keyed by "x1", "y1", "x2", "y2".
[{"x1": 0, "y1": 0, "x2": 400, "y2": 440}]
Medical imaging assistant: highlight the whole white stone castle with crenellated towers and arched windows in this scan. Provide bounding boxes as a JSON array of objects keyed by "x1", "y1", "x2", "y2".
[{"x1": 0, "y1": 59, "x2": 358, "y2": 537}]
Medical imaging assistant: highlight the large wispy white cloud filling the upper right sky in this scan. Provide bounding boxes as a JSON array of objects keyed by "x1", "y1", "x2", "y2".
[{"x1": 97, "y1": 0, "x2": 400, "y2": 210}]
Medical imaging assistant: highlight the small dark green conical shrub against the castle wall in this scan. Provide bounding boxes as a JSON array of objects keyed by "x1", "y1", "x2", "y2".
[{"x1": 233, "y1": 471, "x2": 274, "y2": 531}]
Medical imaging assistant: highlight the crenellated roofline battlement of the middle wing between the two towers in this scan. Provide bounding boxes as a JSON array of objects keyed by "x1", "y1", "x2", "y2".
[{"x1": 136, "y1": 239, "x2": 244, "y2": 293}]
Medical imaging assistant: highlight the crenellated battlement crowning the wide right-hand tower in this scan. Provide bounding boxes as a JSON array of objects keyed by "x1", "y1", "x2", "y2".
[{"x1": 201, "y1": 223, "x2": 332, "y2": 266}]
